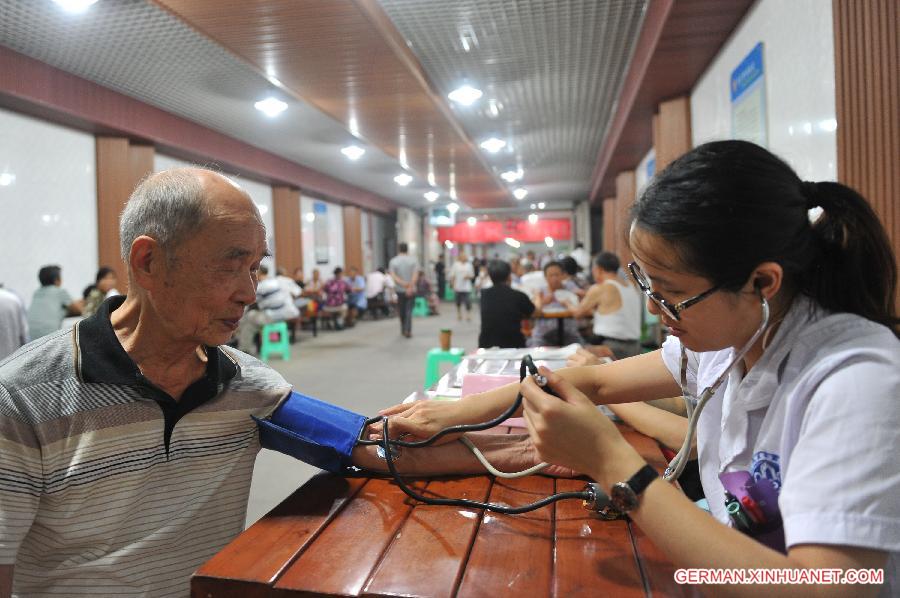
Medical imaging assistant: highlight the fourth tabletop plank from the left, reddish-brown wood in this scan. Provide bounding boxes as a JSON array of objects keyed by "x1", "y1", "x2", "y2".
[{"x1": 457, "y1": 476, "x2": 554, "y2": 598}]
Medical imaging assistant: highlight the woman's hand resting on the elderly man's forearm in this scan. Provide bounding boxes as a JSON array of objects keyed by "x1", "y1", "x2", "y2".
[{"x1": 369, "y1": 401, "x2": 467, "y2": 444}]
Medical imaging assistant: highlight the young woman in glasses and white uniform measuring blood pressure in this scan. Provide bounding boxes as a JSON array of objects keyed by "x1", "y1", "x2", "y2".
[{"x1": 387, "y1": 141, "x2": 900, "y2": 596}]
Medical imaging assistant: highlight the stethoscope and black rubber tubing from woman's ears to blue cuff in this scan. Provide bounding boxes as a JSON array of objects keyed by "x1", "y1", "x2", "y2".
[{"x1": 357, "y1": 296, "x2": 769, "y2": 515}]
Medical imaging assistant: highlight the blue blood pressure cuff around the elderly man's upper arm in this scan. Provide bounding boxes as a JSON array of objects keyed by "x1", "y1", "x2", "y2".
[{"x1": 251, "y1": 391, "x2": 366, "y2": 473}]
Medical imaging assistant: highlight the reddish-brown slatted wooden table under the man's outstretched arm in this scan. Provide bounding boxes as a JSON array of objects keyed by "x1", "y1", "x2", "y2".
[{"x1": 191, "y1": 428, "x2": 699, "y2": 598}]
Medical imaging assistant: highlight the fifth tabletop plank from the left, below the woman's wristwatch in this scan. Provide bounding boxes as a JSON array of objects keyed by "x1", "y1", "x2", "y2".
[{"x1": 553, "y1": 479, "x2": 644, "y2": 598}]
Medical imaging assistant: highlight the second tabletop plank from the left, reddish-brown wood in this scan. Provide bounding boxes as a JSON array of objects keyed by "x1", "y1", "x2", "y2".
[{"x1": 274, "y1": 479, "x2": 424, "y2": 596}]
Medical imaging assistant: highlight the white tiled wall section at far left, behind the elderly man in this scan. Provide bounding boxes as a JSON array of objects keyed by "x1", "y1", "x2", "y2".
[{"x1": 0, "y1": 110, "x2": 96, "y2": 312}]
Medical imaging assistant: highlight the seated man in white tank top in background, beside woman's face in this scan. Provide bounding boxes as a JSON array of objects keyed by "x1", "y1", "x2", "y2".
[{"x1": 571, "y1": 251, "x2": 641, "y2": 359}]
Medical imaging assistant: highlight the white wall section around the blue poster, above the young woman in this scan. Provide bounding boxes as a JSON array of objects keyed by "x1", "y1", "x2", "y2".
[{"x1": 691, "y1": 0, "x2": 837, "y2": 180}]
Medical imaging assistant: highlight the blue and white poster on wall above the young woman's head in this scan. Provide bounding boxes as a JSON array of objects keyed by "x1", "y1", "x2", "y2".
[{"x1": 731, "y1": 42, "x2": 768, "y2": 147}]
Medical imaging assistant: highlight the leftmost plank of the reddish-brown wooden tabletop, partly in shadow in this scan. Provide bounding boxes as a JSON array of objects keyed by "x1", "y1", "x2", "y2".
[{"x1": 191, "y1": 474, "x2": 368, "y2": 597}]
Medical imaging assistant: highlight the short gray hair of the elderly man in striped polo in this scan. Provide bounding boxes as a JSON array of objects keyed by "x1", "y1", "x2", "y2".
[{"x1": 119, "y1": 168, "x2": 209, "y2": 263}]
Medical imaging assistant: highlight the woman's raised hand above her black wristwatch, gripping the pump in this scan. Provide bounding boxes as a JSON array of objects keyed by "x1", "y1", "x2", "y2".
[{"x1": 522, "y1": 367, "x2": 644, "y2": 486}]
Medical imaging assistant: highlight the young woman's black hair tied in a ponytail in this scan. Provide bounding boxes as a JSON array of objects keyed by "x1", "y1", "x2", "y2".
[{"x1": 626, "y1": 140, "x2": 900, "y2": 335}]
